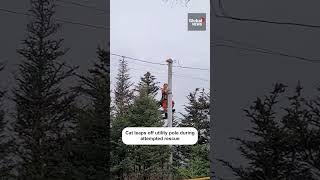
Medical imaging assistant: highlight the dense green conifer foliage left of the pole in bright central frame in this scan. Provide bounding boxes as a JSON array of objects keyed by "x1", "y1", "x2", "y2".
[{"x1": 111, "y1": 75, "x2": 169, "y2": 179}]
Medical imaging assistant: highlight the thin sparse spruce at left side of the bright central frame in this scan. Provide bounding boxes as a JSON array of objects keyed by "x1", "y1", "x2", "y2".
[{"x1": 114, "y1": 58, "x2": 134, "y2": 116}]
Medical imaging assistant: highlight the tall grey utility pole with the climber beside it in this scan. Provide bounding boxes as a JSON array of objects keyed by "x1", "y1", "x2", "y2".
[{"x1": 167, "y1": 59, "x2": 173, "y2": 180}]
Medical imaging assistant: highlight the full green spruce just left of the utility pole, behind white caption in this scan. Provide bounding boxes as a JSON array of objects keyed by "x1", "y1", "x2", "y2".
[{"x1": 126, "y1": 87, "x2": 169, "y2": 180}]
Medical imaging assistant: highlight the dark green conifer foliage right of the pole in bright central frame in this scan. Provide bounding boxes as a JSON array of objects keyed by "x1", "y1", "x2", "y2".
[{"x1": 174, "y1": 89, "x2": 210, "y2": 178}]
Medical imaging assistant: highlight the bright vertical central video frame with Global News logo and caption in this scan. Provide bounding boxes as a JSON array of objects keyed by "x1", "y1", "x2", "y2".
[{"x1": 110, "y1": 0, "x2": 210, "y2": 180}]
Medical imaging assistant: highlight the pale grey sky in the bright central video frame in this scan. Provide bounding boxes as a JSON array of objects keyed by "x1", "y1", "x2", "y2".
[{"x1": 110, "y1": 0, "x2": 210, "y2": 115}]
